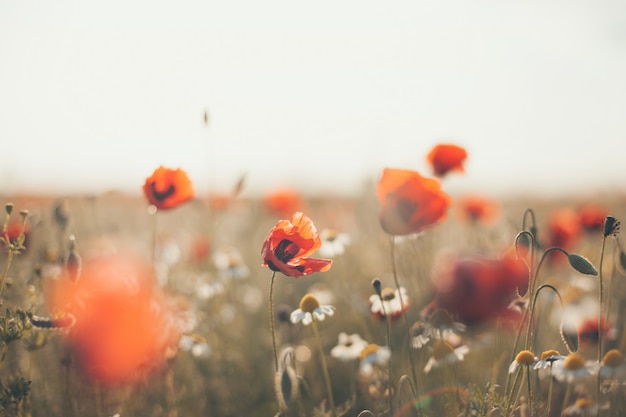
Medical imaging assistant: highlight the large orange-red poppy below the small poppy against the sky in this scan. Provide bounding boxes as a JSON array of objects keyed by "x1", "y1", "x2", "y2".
[{"x1": 376, "y1": 168, "x2": 451, "y2": 235}]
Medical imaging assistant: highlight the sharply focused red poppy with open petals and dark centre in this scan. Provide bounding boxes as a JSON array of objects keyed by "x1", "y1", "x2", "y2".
[{"x1": 261, "y1": 212, "x2": 333, "y2": 278}]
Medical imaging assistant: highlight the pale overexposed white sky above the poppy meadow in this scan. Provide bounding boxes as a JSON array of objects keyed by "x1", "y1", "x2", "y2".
[{"x1": 0, "y1": 0, "x2": 626, "y2": 194}]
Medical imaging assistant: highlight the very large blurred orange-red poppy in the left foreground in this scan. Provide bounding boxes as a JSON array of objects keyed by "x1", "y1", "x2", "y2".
[{"x1": 47, "y1": 250, "x2": 179, "y2": 384}]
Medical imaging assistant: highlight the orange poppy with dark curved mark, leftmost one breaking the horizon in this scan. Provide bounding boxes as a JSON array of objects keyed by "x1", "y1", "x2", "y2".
[{"x1": 143, "y1": 166, "x2": 195, "y2": 210}]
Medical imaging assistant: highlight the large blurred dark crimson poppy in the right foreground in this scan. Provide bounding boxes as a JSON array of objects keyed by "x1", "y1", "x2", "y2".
[{"x1": 433, "y1": 250, "x2": 528, "y2": 325}]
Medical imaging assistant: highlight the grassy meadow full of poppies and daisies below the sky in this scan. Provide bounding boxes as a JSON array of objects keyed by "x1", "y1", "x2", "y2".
[{"x1": 0, "y1": 162, "x2": 626, "y2": 417}]
